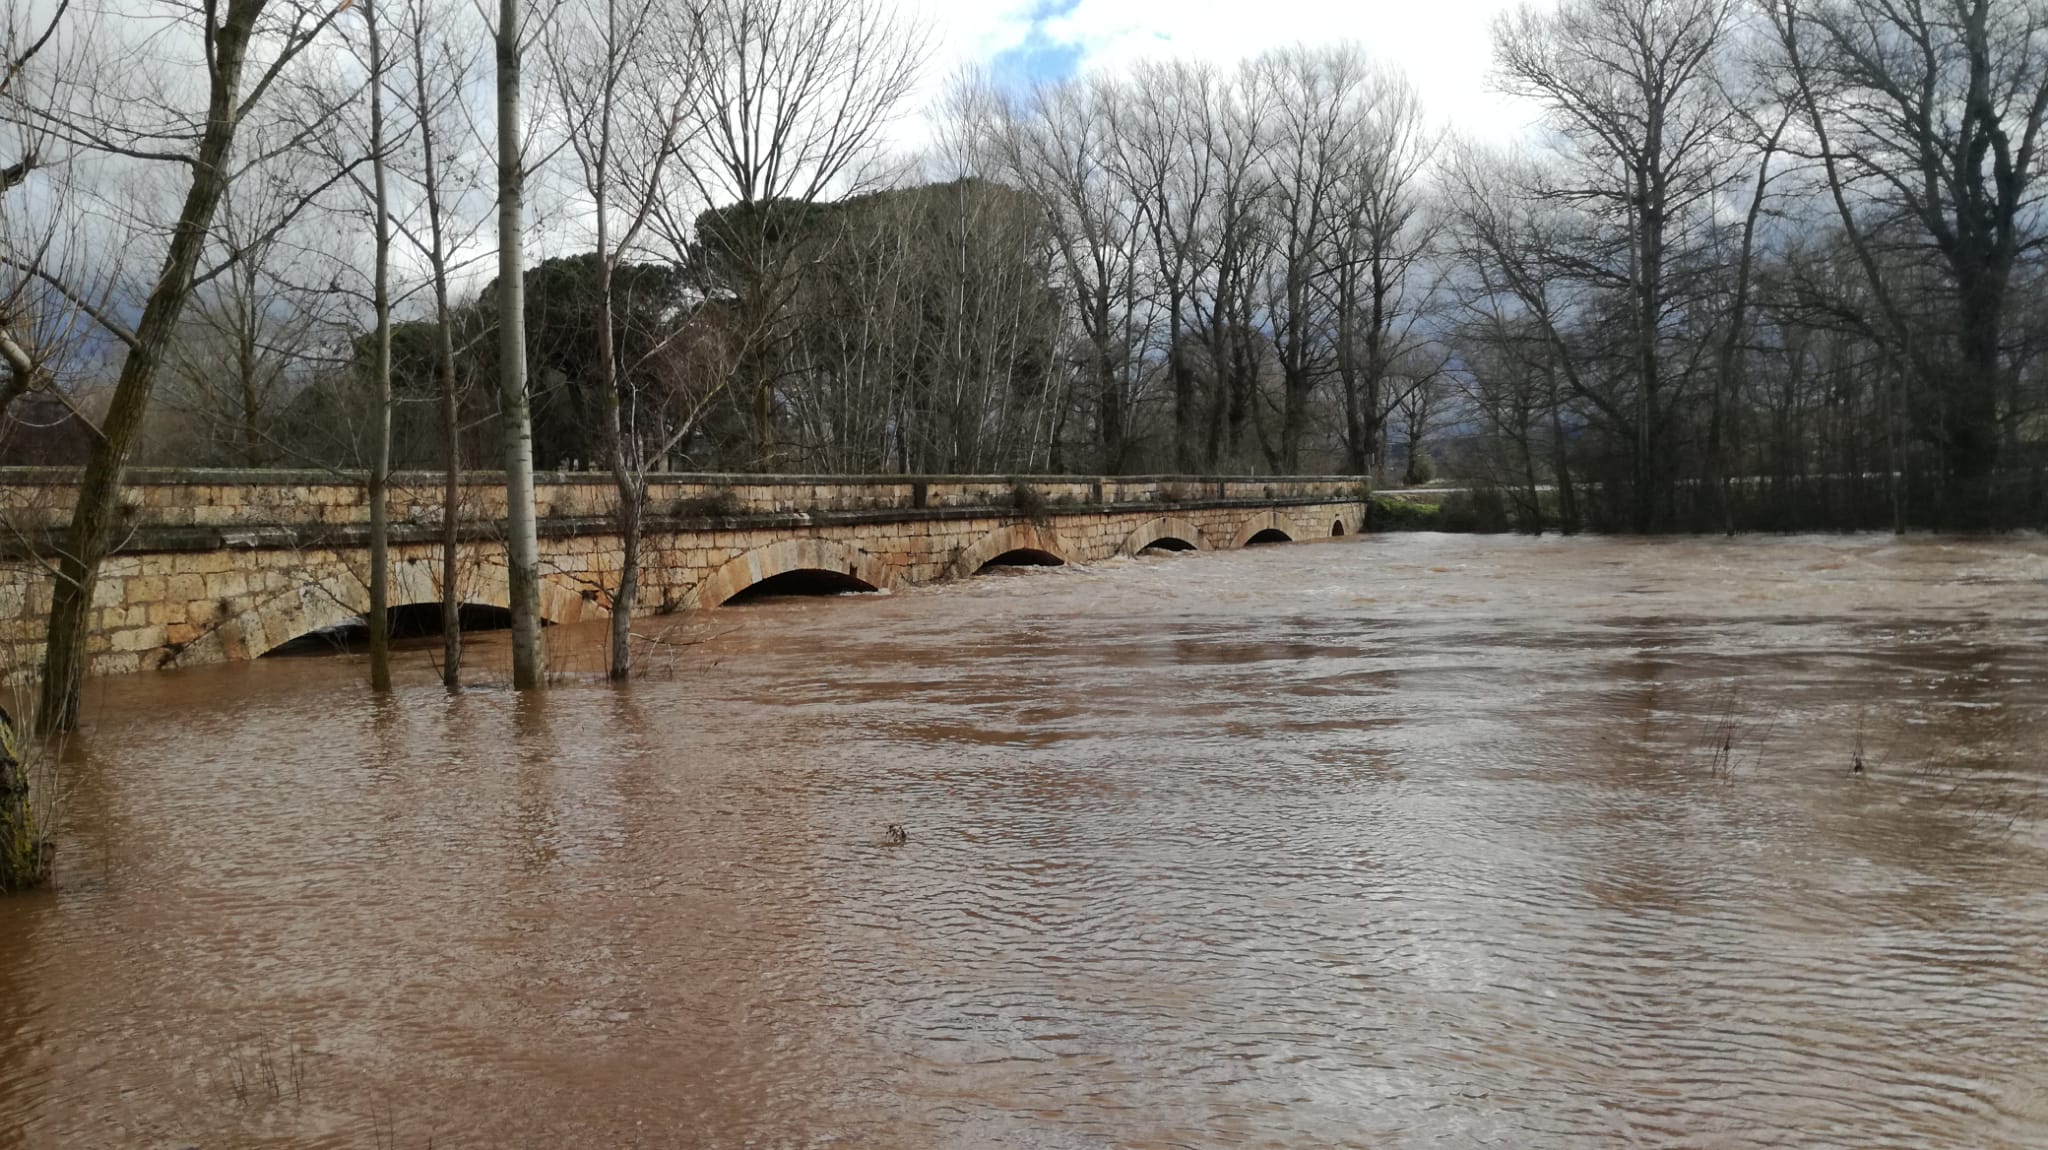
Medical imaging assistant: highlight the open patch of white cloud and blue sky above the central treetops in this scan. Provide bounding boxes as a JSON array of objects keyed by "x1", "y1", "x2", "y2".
[{"x1": 903, "y1": 0, "x2": 1534, "y2": 141}]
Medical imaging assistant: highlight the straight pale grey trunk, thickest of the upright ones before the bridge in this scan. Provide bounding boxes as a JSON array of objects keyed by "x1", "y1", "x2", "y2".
[{"x1": 498, "y1": 0, "x2": 541, "y2": 690}]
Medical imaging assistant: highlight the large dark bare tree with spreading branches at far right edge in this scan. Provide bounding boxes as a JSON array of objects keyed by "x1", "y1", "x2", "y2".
[{"x1": 1765, "y1": 0, "x2": 2048, "y2": 526}]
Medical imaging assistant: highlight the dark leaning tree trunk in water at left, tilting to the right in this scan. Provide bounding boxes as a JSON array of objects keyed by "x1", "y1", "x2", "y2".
[{"x1": 35, "y1": 0, "x2": 262, "y2": 735}]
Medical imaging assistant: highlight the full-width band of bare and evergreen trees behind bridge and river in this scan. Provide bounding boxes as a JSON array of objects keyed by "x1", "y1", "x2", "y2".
[{"x1": 0, "y1": 0, "x2": 2048, "y2": 679}]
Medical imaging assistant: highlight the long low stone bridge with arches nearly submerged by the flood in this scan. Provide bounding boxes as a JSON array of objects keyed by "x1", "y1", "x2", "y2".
[{"x1": 0, "y1": 469, "x2": 1364, "y2": 675}]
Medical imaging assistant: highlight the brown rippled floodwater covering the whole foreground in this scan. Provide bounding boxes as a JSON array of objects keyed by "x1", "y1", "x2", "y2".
[{"x1": 0, "y1": 536, "x2": 2048, "y2": 1148}]
